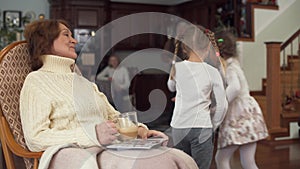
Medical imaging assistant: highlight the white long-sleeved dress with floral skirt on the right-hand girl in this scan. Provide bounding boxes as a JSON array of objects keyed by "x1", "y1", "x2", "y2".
[{"x1": 218, "y1": 58, "x2": 268, "y2": 148}]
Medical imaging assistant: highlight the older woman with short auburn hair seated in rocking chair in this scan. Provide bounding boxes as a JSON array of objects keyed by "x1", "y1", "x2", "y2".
[{"x1": 20, "y1": 20, "x2": 195, "y2": 169}]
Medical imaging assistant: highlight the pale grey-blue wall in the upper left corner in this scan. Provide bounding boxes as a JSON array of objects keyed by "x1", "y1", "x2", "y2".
[{"x1": 0, "y1": 0, "x2": 49, "y2": 24}]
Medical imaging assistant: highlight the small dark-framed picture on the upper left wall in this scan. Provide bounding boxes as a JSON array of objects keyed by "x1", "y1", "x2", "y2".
[{"x1": 3, "y1": 10, "x2": 22, "y2": 28}]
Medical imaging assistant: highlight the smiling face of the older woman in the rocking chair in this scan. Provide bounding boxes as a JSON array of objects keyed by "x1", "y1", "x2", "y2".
[{"x1": 52, "y1": 23, "x2": 77, "y2": 59}]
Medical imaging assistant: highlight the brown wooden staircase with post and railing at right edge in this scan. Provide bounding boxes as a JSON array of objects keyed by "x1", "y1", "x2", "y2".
[{"x1": 251, "y1": 29, "x2": 300, "y2": 140}]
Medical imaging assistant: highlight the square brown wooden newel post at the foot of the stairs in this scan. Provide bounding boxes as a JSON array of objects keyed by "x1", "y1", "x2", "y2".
[{"x1": 265, "y1": 42, "x2": 282, "y2": 138}]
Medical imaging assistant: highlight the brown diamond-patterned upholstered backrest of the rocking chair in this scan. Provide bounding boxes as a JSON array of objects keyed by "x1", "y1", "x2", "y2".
[{"x1": 0, "y1": 43, "x2": 32, "y2": 168}]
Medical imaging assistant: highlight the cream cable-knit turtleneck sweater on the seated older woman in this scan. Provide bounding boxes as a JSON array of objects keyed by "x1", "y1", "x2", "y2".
[{"x1": 20, "y1": 55, "x2": 119, "y2": 151}]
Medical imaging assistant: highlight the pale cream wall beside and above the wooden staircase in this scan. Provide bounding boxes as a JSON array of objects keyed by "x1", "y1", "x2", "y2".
[{"x1": 240, "y1": 0, "x2": 300, "y2": 90}]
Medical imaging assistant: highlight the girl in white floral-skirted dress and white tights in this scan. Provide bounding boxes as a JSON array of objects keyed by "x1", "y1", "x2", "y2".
[{"x1": 215, "y1": 31, "x2": 268, "y2": 169}]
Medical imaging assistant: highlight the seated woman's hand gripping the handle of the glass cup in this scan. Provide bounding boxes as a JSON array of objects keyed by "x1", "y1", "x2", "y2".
[{"x1": 96, "y1": 121, "x2": 118, "y2": 145}]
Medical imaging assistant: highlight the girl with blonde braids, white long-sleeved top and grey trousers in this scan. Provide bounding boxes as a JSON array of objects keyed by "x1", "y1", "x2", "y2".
[{"x1": 168, "y1": 25, "x2": 227, "y2": 169}]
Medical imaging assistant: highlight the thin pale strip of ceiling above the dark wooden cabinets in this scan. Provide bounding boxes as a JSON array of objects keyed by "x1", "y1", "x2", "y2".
[{"x1": 110, "y1": 0, "x2": 191, "y2": 5}]
